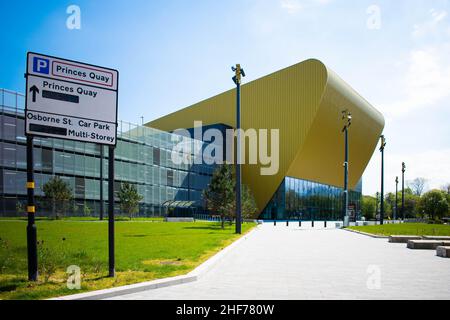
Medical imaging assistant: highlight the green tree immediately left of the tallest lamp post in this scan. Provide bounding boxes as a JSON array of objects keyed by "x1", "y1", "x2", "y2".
[{"x1": 203, "y1": 164, "x2": 234, "y2": 229}]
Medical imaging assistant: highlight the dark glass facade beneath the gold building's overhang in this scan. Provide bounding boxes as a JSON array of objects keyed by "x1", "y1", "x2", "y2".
[{"x1": 260, "y1": 177, "x2": 362, "y2": 221}]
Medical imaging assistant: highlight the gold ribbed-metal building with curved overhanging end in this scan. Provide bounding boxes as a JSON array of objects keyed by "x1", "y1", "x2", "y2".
[{"x1": 147, "y1": 59, "x2": 384, "y2": 217}]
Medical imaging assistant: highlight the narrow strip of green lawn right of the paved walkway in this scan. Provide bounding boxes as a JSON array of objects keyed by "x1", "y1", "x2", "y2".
[{"x1": 349, "y1": 223, "x2": 450, "y2": 236}]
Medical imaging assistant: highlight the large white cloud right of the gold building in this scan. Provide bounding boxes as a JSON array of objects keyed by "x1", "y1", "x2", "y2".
[{"x1": 363, "y1": 9, "x2": 450, "y2": 194}]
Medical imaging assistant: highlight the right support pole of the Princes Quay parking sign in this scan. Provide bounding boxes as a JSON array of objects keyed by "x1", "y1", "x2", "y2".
[{"x1": 108, "y1": 147, "x2": 116, "y2": 277}]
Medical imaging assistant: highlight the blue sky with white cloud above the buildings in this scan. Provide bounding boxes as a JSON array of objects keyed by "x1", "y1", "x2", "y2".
[{"x1": 0, "y1": 0, "x2": 450, "y2": 194}]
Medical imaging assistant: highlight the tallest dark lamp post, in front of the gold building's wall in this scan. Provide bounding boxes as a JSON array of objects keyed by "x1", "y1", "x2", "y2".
[{"x1": 231, "y1": 64, "x2": 245, "y2": 234}]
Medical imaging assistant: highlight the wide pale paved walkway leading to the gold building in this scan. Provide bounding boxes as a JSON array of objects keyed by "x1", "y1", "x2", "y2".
[{"x1": 108, "y1": 224, "x2": 450, "y2": 300}]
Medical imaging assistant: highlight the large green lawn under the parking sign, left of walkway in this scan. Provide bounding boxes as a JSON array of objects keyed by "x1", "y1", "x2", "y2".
[{"x1": 0, "y1": 220, "x2": 255, "y2": 299}]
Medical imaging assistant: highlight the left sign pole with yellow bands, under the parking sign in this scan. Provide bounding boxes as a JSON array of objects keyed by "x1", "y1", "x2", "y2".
[{"x1": 27, "y1": 136, "x2": 38, "y2": 281}]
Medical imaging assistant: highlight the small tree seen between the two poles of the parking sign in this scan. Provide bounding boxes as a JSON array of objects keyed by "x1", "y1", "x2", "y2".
[{"x1": 42, "y1": 177, "x2": 73, "y2": 219}]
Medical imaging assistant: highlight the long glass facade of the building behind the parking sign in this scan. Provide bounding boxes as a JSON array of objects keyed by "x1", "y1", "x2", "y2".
[{"x1": 0, "y1": 89, "x2": 215, "y2": 216}]
